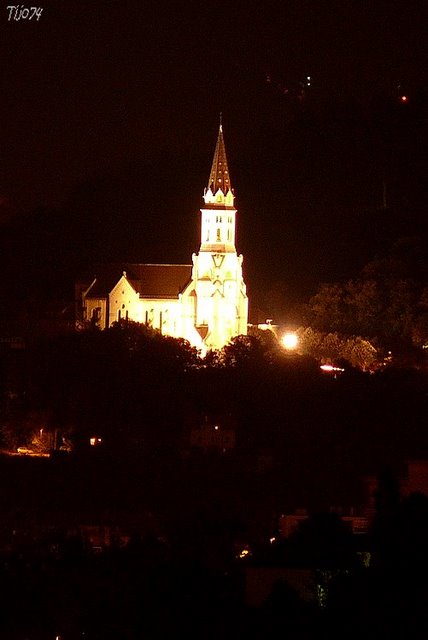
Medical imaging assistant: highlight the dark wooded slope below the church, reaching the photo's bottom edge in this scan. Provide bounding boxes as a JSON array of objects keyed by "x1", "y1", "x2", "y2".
[{"x1": 0, "y1": 323, "x2": 428, "y2": 640}]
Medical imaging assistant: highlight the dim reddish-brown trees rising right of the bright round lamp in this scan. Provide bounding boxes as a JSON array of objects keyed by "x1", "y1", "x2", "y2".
[{"x1": 308, "y1": 238, "x2": 428, "y2": 348}]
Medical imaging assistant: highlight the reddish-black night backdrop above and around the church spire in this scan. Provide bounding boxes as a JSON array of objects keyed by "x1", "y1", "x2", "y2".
[{"x1": 0, "y1": 0, "x2": 428, "y2": 310}]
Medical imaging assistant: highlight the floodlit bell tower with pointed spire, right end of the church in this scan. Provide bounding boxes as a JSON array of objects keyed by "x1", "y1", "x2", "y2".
[{"x1": 192, "y1": 122, "x2": 248, "y2": 349}]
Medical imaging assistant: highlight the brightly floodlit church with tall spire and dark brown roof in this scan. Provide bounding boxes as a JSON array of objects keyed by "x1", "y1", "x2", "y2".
[{"x1": 78, "y1": 124, "x2": 248, "y2": 352}]
